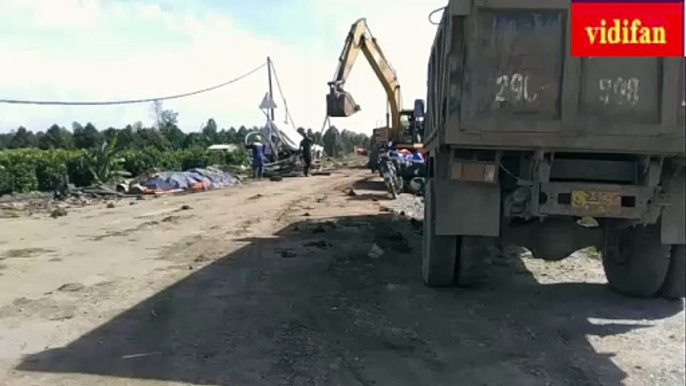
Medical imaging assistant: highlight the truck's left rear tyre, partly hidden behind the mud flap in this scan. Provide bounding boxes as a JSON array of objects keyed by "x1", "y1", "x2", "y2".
[{"x1": 422, "y1": 179, "x2": 457, "y2": 287}]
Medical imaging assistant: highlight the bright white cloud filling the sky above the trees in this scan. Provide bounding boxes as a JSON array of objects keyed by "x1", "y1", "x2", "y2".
[{"x1": 0, "y1": 0, "x2": 445, "y2": 132}]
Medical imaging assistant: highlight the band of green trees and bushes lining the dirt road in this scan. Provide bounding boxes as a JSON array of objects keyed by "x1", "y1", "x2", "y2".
[{"x1": 0, "y1": 104, "x2": 368, "y2": 195}]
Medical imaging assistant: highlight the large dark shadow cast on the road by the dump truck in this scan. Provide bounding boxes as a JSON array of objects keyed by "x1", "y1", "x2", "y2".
[{"x1": 16, "y1": 215, "x2": 682, "y2": 386}]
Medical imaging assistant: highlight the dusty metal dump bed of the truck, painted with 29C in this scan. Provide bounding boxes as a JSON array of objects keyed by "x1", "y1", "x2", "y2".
[{"x1": 425, "y1": 0, "x2": 686, "y2": 155}]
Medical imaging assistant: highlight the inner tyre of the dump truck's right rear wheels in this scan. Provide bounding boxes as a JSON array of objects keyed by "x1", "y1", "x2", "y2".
[{"x1": 603, "y1": 226, "x2": 670, "y2": 297}]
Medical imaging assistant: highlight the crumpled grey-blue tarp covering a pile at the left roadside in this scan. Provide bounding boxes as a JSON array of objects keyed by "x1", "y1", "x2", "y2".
[{"x1": 141, "y1": 168, "x2": 240, "y2": 190}]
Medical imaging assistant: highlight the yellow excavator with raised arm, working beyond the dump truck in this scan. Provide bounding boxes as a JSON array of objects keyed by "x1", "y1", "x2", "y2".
[{"x1": 326, "y1": 18, "x2": 424, "y2": 150}]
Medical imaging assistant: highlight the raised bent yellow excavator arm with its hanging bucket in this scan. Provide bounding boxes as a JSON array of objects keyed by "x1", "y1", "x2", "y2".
[{"x1": 326, "y1": 19, "x2": 402, "y2": 139}]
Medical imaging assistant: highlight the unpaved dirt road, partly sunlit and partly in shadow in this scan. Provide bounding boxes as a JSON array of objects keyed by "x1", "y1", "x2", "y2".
[{"x1": 0, "y1": 170, "x2": 684, "y2": 386}]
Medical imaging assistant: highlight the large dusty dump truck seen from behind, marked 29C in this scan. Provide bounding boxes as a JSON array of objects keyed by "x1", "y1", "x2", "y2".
[{"x1": 422, "y1": 0, "x2": 686, "y2": 298}]
